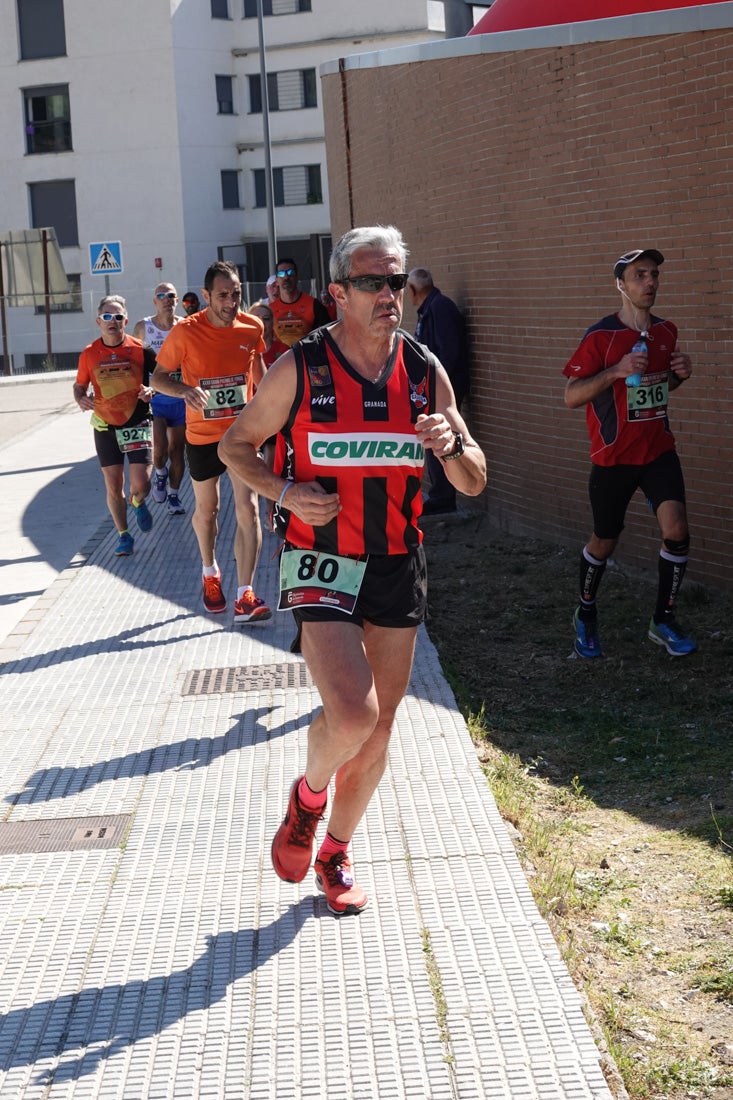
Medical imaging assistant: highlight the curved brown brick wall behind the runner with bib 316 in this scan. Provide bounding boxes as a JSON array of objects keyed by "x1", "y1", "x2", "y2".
[{"x1": 324, "y1": 29, "x2": 733, "y2": 587}]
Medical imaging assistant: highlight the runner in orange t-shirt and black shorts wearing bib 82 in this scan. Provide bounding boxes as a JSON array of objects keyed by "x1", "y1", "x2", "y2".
[{"x1": 151, "y1": 261, "x2": 272, "y2": 625}]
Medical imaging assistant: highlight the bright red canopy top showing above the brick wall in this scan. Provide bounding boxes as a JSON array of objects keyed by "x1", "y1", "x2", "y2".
[{"x1": 469, "y1": 0, "x2": 716, "y2": 34}]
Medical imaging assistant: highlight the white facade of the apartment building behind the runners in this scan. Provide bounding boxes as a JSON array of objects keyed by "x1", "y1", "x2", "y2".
[{"x1": 0, "y1": 0, "x2": 451, "y2": 371}]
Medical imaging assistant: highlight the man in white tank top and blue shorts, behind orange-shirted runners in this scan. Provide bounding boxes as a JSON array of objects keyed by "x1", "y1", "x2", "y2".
[{"x1": 132, "y1": 283, "x2": 186, "y2": 516}]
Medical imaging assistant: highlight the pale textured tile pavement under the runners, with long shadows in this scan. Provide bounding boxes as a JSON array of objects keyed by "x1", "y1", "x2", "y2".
[{"x1": 0, "y1": 387, "x2": 611, "y2": 1100}]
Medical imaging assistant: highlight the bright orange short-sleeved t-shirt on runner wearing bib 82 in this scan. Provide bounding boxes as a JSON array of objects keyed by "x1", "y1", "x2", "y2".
[{"x1": 156, "y1": 309, "x2": 265, "y2": 444}]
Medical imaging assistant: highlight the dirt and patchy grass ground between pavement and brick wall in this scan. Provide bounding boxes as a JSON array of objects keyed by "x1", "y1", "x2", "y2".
[{"x1": 426, "y1": 516, "x2": 733, "y2": 1100}]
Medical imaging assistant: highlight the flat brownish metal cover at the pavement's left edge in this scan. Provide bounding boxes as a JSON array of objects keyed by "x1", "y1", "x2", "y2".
[{"x1": 0, "y1": 814, "x2": 132, "y2": 856}]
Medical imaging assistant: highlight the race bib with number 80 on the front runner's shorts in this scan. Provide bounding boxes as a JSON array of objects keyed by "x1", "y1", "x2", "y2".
[{"x1": 277, "y1": 547, "x2": 367, "y2": 615}]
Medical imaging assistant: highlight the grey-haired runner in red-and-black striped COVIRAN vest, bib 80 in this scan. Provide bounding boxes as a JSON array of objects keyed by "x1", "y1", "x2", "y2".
[{"x1": 219, "y1": 226, "x2": 485, "y2": 915}]
